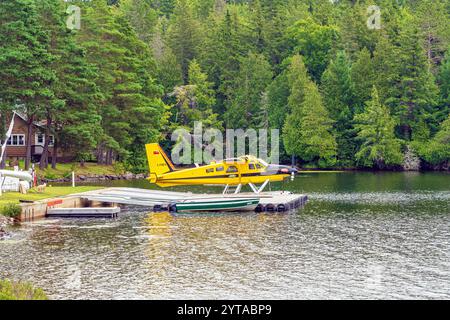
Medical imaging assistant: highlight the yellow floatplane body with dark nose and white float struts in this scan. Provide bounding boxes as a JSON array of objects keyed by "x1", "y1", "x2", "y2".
[{"x1": 145, "y1": 143, "x2": 297, "y2": 194}]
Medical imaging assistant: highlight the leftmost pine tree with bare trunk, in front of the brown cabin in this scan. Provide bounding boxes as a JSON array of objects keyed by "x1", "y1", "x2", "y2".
[{"x1": 0, "y1": 0, "x2": 57, "y2": 169}]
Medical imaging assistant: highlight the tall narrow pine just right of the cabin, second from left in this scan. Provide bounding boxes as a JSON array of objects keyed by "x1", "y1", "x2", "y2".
[{"x1": 37, "y1": 0, "x2": 94, "y2": 170}]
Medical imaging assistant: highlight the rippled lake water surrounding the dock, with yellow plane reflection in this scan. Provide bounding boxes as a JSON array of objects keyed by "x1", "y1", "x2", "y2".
[{"x1": 0, "y1": 173, "x2": 450, "y2": 299}]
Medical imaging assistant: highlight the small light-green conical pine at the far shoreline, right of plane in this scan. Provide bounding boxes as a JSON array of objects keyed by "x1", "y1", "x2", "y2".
[{"x1": 355, "y1": 86, "x2": 403, "y2": 169}]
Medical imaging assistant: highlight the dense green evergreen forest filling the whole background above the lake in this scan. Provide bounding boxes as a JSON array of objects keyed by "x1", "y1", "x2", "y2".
[{"x1": 0, "y1": 0, "x2": 450, "y2": 171}]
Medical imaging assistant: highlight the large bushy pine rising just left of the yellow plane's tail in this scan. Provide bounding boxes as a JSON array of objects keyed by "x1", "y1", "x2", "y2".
[{"x1": 79, "y1": 2, "x2": 166, "y2": 168}]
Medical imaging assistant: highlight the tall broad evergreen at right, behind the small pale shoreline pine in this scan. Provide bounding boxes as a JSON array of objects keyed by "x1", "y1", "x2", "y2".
[{"x1": 375, "y1": 9, "x2": 438, "y2": 140}]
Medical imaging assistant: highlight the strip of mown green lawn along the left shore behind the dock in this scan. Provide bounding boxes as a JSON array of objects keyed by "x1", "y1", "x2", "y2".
[{"x1": 0, "y1": 186, "x2": 102, "y2": 208}]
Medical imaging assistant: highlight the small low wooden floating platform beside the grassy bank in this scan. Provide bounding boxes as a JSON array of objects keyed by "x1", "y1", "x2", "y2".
[{"x1": 47, "y1": 207, "x2": 120, "y2": 218}]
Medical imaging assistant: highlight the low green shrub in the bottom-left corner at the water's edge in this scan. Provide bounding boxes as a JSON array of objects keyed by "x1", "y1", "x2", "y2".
[{"x1": 0, "y1": 280, "x2": 48, "y2": 300}]
